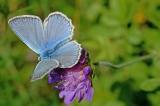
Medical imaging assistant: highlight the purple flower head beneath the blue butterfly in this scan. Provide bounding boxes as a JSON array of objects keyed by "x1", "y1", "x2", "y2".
[{"x1": 48, "y1": 49, "x2": 94, "y2": 104}]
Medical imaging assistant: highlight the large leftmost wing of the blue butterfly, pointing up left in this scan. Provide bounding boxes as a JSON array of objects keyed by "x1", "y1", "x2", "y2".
[{"x1": 8, "y1": 15, "x2": 44, "y2": 54}]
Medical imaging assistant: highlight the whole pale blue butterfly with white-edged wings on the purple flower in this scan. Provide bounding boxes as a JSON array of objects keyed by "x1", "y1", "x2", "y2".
[{"x1": 8, "y1": 12, "x2": 82, "y2": 81}]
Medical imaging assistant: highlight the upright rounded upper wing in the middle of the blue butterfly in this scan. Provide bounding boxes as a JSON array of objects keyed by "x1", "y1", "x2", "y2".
[{"x1": 43, "y1": 12, "x2": 74, "y2": 49}]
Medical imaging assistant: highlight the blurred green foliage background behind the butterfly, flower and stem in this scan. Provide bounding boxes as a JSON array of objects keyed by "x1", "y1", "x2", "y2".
[{"x1": 0, "y1": 0, "x2": 160, "y2": 106}]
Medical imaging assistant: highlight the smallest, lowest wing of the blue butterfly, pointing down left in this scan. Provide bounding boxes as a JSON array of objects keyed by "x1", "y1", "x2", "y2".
[{"x1": 31, "y1": 59, "x2": 59, "y2": 81}]
